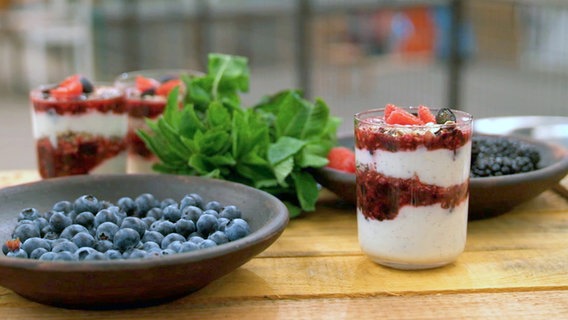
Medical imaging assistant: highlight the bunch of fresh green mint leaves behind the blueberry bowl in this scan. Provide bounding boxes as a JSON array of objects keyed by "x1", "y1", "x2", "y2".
[{"x1": 138, "y1": 54, "x2": 340, "y2": 217}]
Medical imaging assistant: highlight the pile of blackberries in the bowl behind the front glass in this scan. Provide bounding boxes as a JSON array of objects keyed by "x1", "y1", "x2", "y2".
[{"x1": 470, "y1": 136, "x2": 540, "y2": 178}]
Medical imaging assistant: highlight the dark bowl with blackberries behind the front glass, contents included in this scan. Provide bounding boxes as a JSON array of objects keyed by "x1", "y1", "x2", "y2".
[{"x1": 314, "y1": 134, "x2": 568, "y2": 220}]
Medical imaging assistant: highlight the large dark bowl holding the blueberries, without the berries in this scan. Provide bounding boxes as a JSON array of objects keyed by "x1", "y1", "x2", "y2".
[{"x1": 0, "y1": 174, "x2": 288, "y2": 309}]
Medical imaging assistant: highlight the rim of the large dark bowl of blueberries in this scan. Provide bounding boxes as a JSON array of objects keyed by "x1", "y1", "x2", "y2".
[{"x1": 0, "y1": 174, "x2": 289, "y2": 272}]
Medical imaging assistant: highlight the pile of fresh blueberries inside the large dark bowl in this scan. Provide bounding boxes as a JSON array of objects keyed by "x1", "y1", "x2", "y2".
[{"x1": 2, "y1": 193, "x2": 250, "y2": 261}]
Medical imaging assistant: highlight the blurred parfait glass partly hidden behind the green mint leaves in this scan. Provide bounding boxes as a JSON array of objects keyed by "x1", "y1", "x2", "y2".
[{"x1": 115, "y1": 69, "x2": 203, "y2": 173}]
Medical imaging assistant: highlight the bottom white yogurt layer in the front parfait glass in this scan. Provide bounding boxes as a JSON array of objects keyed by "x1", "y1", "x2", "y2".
[{"x1": 357, "y1": 199, "x2": 468, "y2": 269}]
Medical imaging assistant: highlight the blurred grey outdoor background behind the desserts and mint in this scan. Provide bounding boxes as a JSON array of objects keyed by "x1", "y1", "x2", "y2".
[{"x1": 0, "y1": 0, "x2": 568, "y2": 170}]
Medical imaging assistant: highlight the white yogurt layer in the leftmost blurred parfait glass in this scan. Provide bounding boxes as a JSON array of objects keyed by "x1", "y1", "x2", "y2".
[{"x1": 32, "y1": 110, "x2": 128, "y2": 146}]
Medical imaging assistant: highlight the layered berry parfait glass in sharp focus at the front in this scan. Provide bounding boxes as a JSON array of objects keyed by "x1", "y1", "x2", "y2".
[{"x1": 355, "y1": 105, "x2": 472, "y2": 269}]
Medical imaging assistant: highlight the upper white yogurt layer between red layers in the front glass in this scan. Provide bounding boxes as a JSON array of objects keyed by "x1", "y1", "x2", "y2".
[{"x1": 355, "y1": 141, "x2": 471, "y2": 187}]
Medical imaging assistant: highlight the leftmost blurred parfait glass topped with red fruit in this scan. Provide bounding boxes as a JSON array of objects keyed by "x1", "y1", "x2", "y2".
[{"x1": 30, "y1": 75, "x2": 127, "y2": 178}]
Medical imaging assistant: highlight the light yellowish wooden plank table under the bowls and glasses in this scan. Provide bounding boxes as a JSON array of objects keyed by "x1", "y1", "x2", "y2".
[{"x1": 0, "y1": 171, "x2": 568, "y2": 320}]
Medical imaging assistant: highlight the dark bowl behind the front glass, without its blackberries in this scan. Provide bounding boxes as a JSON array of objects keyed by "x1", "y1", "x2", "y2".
[{"x1": 314, "y1": 136, "x2": 568, "y2": 220}]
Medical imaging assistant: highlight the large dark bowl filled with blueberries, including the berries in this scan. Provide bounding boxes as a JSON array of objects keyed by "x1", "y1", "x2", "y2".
[{"x1": 0, "y1": 174, "x2": 288, "y2": 309}]
